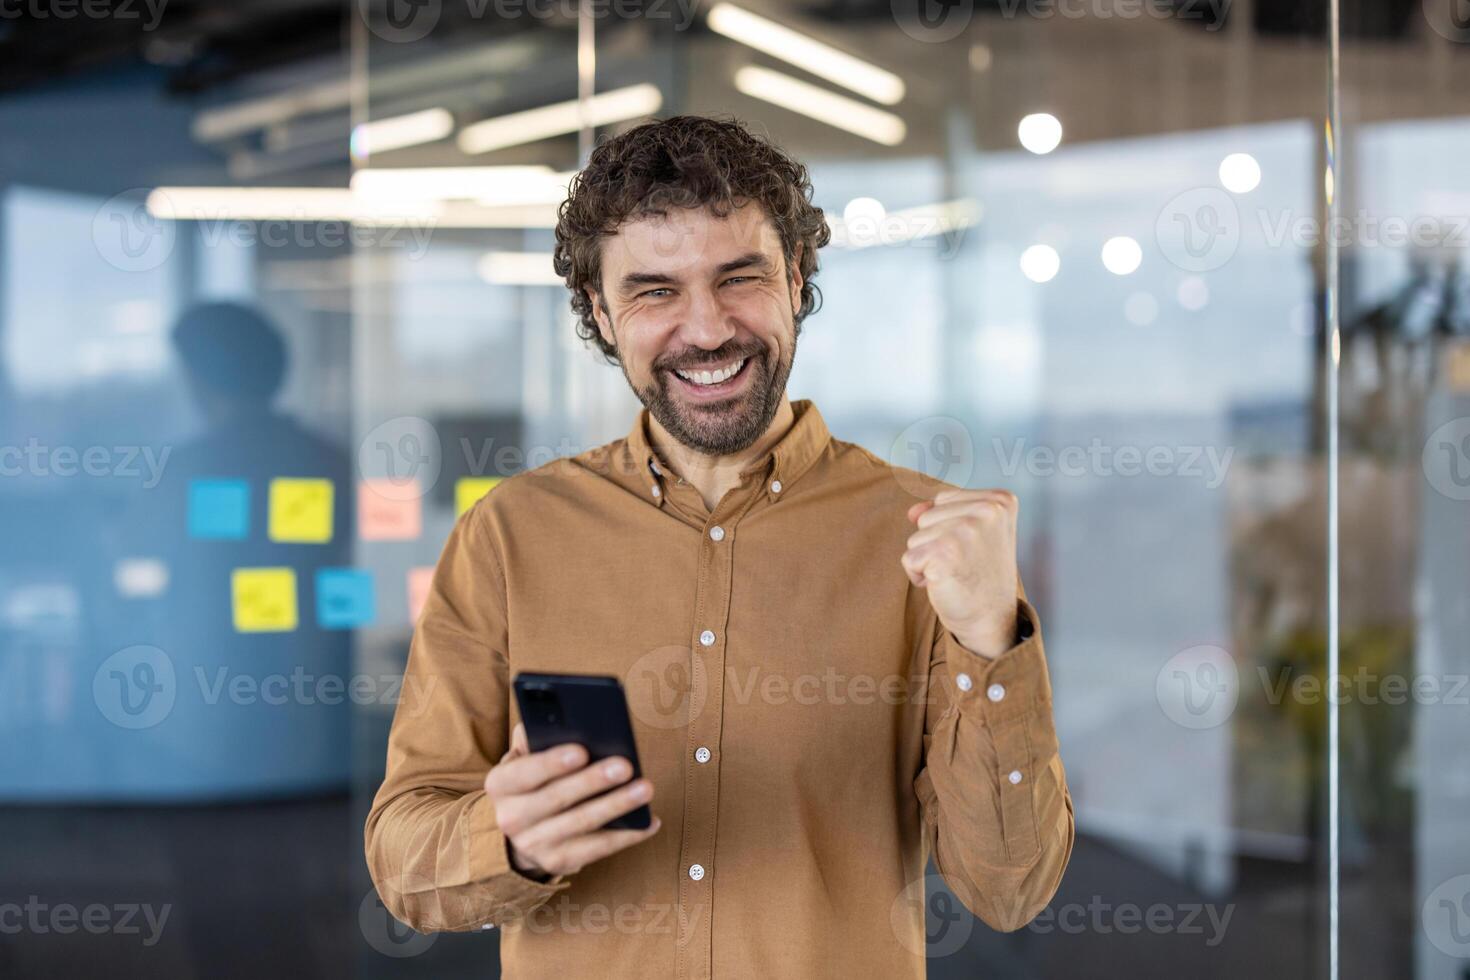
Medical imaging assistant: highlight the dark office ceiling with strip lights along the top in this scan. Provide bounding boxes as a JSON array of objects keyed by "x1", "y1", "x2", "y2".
[{"x1": 0, "y1": 0, "x2": 1470, "y2": 182}]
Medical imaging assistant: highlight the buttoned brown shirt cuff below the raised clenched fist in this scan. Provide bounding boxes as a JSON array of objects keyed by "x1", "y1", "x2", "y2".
[{"x1": 939, "y1": 598, "x2": 1051, "y2": 726}]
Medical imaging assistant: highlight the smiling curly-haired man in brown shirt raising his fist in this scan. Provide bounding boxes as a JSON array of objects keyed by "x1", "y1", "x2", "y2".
[{"x1": 366, "y1": 116, "x2": 1073, "y2": 980}]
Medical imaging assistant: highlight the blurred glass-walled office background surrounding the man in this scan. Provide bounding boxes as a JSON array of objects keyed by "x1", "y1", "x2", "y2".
[{"x1": 0, "y1": 0, "x2": 1470, "y2": 980}]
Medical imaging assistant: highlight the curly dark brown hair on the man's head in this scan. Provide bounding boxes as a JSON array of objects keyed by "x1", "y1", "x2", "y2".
[{"x1": 553, "y1": 116, "x2": 832, "y2": 364}]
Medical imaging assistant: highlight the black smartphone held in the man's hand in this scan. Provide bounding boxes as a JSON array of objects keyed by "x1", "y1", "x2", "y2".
[{"x1": 513, "y1": 673, "x2": 653, "y2": 830}]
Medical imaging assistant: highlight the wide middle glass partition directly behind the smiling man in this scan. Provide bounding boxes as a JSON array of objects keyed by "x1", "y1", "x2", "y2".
[{"x1": 354, "y1": 3, "x2": 1330, "y2": 977}]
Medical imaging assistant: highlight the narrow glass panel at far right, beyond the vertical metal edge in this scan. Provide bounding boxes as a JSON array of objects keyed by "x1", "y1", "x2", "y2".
[{"x1": 1339, "y1": 3, "x2": 1470, "y2": 980}]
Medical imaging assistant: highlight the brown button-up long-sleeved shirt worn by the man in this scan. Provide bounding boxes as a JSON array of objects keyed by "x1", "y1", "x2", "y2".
[{"x1": 366, "y1": 401, "x2": 1073, "y2": 980}]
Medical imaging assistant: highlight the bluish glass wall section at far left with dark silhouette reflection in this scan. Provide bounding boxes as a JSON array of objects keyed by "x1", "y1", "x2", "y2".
[{"x1": 0, "y1": 59, "x2": 361, "y2": 977}]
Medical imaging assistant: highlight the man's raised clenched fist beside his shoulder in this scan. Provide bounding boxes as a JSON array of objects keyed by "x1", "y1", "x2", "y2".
[{"x1": 903, "y1": 489, "x2": 1020, "y2": 657}]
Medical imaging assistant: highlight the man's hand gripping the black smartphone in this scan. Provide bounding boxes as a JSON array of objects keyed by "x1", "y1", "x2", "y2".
[{"x1": 485, "y1": 724, "x2": 659, "y2": 877}]
